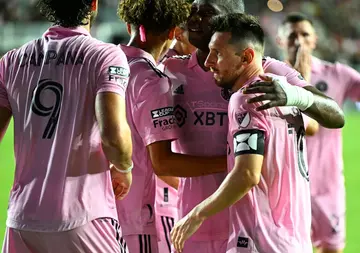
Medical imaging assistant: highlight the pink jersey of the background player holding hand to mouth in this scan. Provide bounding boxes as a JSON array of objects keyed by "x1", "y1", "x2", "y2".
[{"x1": 306, "y1": 57, "x2": 360, "y2": 196}]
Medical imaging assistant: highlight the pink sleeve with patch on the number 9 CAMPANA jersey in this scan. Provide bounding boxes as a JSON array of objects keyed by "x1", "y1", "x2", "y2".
[{"x1": 97, "y1": 46, "x2": 130, "y2": 98}]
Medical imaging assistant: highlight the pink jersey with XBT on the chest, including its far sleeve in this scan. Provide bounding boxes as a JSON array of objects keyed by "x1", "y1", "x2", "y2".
[{"x1": 162, "y1": 52, "x2": 307, "y2": 241}]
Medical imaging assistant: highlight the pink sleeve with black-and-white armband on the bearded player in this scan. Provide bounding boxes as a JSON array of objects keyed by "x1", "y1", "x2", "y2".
[{"x1": 229, "y1": 91, "x2": 269, "y2": 157}]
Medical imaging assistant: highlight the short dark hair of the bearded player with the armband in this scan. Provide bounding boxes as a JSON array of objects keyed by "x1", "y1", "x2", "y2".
[{"x1": 210, "y1": 13, "x2": 265, "y2": 53}]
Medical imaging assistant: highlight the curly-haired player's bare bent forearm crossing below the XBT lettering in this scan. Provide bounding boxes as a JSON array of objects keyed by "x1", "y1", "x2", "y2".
[{"x1": 147, "y1": 141, "x2": 226, "y2": 177}]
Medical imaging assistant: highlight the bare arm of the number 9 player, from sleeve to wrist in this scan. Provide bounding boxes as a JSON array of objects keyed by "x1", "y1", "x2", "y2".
[{"x1": 95, "y1": 92, "x2": 132, "y2": 170}]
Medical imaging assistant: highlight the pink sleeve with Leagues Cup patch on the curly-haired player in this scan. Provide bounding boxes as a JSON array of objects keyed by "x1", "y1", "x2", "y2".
[{"x1": 132, "y1": 76, "x2": 177, "y2": 146}]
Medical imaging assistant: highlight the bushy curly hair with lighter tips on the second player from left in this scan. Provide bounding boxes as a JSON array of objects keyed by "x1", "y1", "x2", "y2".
[{"x1": 118, "y1": 0, "x2": 190, "y2": 33}]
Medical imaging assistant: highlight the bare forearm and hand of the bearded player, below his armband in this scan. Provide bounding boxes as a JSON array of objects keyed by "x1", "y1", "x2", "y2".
[{"x1": 171, "y1": 130, "x2": 264, "y2": 252}]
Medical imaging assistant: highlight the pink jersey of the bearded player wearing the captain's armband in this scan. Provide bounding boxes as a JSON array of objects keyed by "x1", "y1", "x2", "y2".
[{"x1": 227, "y1": 77, "x2": 312, "y2": 253}]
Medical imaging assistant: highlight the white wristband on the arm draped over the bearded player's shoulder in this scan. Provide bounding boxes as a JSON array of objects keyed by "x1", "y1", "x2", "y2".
[{"x1": 277, "y1": 78, "x2": 314, "y2": 111}]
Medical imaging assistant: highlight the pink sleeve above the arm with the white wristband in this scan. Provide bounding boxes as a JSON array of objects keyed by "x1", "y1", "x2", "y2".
[{"x1": 263, "y1": 57, "x2": 309, "y2": 87}]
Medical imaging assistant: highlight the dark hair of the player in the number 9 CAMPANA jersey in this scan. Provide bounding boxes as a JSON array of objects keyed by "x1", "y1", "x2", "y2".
[{"x1": 37, "y1": 0, "x2": 92, "y2": 27}]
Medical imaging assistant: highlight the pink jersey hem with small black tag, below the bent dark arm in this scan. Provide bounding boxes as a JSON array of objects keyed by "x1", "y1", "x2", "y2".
[{"x1": 155, "y1": 178, "x2": 178, "y2": 220}]
